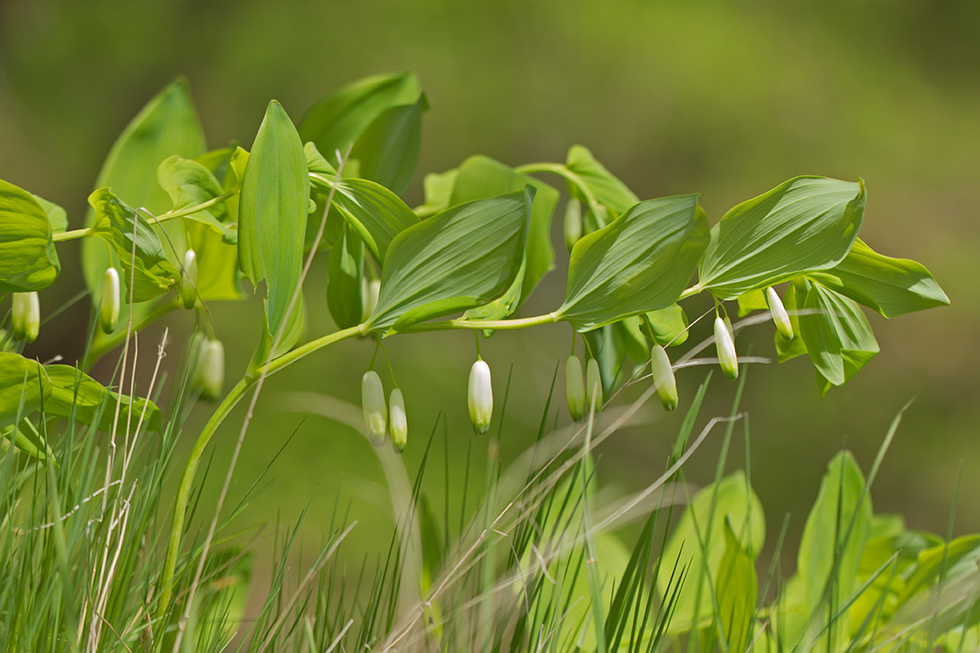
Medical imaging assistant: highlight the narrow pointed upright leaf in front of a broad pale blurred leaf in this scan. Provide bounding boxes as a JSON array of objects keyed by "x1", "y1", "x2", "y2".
[{"x1": 715, "y1": 517, "x2": 759, "y2": 651}]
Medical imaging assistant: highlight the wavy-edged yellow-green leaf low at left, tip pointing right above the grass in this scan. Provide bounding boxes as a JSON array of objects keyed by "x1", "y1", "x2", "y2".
[{"x1": 44, "y1": 365, "x2": 162, "y2": 434}]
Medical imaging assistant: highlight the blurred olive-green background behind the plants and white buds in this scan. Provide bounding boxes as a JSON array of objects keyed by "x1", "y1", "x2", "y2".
[{"x1": 0, "y1": 0, "x2": 980, "y2": 596}]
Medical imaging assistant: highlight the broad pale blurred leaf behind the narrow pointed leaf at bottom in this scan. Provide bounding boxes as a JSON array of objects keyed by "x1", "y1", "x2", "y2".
[{"x1": 657, "y1": 471, "x2": 766, "y2": 634}]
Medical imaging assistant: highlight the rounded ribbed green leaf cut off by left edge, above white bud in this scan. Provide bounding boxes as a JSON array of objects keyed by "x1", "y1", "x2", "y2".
[{"x1": 0, "y1": 179, "x2": 61, "y2": 292}]
